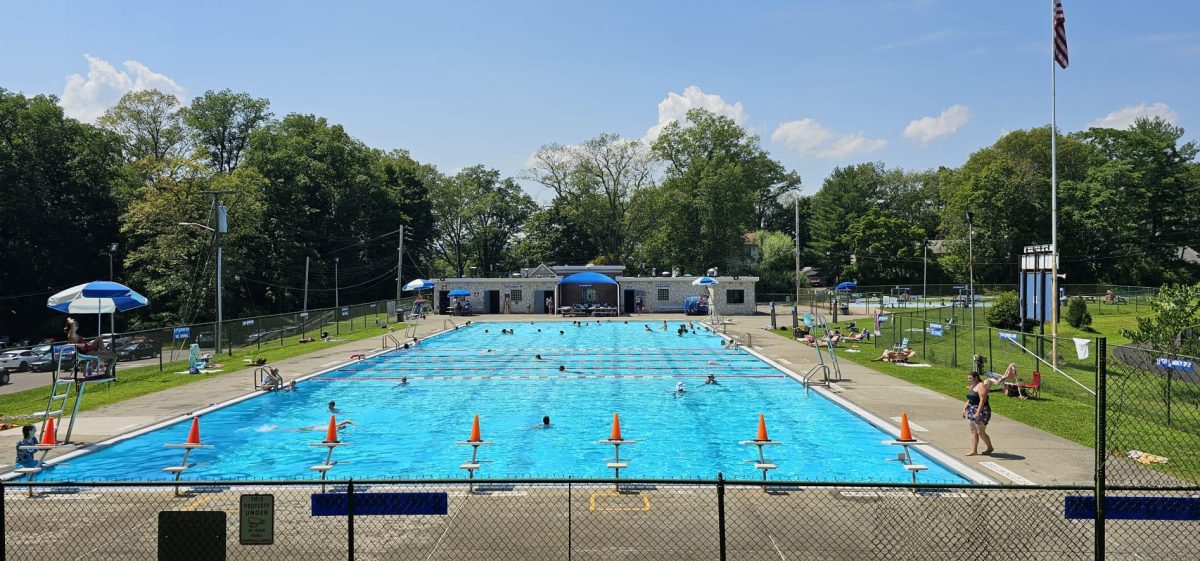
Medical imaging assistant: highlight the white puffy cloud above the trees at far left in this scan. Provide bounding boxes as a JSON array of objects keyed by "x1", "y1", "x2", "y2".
[{"x1": 59, "y1": 54, "x2": 184, "y2": 122}]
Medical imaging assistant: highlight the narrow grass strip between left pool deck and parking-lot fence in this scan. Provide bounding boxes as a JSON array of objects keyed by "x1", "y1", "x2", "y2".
[{"x1": 0, "y1": 324, "x2": 404, "y2": 423}]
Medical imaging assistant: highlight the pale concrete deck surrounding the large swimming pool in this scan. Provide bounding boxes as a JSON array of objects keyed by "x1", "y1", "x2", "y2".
[{"x1": 0, "y1": 314, "x2": 1094, "y2": 484}]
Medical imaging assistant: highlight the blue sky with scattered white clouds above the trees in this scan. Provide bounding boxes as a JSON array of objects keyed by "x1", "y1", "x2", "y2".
[{"x1": 0, "y1": 0, "x2": 1200, "y2": 201}]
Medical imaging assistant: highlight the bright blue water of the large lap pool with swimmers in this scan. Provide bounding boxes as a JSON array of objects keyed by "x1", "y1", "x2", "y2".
[{"x1": 28, "y1": 320, "x2": 966, "y2": 483}]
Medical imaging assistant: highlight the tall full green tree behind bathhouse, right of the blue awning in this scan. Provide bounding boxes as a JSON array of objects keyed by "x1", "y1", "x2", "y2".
[{"x1": 653, "y1": 109, "x2": 799, "y2": 271}]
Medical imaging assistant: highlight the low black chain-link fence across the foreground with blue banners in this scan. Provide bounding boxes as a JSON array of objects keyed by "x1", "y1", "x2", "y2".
[{"x1": 0, "y1": 479, "x2": 1200, "y2": 561}]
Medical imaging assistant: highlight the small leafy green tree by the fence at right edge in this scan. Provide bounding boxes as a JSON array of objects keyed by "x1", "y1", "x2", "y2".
[{"x1": 1121, "y1": 284, "x2": 1200, "y2": 356}]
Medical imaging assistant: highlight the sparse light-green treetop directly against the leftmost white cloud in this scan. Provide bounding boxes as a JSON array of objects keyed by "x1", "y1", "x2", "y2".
[{"x1": 97, "y1": 90, "x2": 188, "y2": 162}]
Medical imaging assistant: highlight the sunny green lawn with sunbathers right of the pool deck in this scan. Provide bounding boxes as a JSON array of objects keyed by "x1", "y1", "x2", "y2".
[{"x1": 776, "y1": 304, "x2": 1200, "y2": 482}]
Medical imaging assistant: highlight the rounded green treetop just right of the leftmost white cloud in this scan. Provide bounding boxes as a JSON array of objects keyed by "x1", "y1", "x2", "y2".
[{"x1": 182, "y1": 89, "x2": 271, "y2": 174}]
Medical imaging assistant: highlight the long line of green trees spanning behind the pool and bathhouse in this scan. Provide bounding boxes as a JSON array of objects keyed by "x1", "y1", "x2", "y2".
[{"x1": 0, "y1": 84, "x2": 1200, "y2": 337}]
